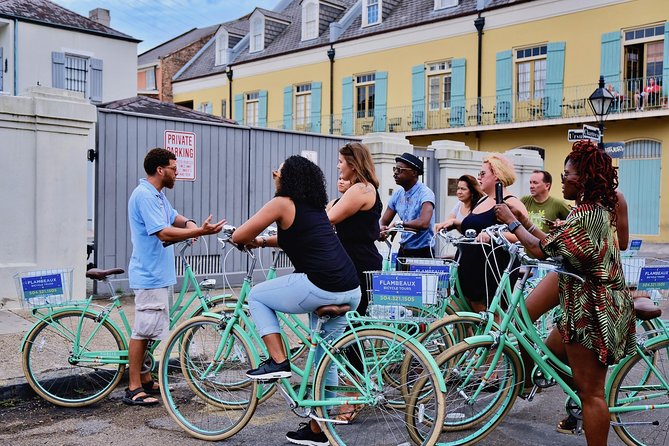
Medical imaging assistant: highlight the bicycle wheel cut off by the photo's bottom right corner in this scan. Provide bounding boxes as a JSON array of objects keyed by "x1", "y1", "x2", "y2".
[{"x1": 609, "y1": 338, "x2": 669, "y2": 446}]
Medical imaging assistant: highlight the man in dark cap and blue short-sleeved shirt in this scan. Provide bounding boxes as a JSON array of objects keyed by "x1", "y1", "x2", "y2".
[{"x1": 381, "y1": 153, "x2": 435, "y2": 257}]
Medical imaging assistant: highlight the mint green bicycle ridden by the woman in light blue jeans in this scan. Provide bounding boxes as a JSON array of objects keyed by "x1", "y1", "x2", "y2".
[{"x1": 159, "y1": 229, "x2": 445, "y2": 445}]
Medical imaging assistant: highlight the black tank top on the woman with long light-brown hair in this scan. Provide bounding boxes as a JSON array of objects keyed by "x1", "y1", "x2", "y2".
[{"x1": 335, "y1": 190, "x2": 383, "y2": 273}]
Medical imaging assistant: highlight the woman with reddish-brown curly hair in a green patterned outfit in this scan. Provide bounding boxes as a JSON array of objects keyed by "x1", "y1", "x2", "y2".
[{"x1": 496, "y1": 141, "x2": 635, "y2": 446}]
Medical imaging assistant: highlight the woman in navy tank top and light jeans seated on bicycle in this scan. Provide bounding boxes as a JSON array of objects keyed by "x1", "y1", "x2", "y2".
[{"x1": 232, "y1": 156, "x2": 360, "y2": 444}]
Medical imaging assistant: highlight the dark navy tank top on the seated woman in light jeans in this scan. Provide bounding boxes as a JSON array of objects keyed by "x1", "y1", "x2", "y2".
[{"x1": 277, "y1": 201, "x2": 360, "y2": 292}]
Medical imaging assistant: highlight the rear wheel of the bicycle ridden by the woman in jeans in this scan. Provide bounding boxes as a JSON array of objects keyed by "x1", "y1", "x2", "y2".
[{"x1": 314, "y1": 329, "x2": 444, "y2": 446}]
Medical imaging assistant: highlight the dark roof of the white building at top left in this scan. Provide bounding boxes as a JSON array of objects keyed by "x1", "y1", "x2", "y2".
[{"x1": 0, "y1": 0, "x2": 141, "y2": 42}]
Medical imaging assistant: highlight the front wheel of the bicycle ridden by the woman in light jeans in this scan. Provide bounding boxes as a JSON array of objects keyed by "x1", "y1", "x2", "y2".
[{"x1": 159, "y1": 316, "x2": 258, "y2": 441}]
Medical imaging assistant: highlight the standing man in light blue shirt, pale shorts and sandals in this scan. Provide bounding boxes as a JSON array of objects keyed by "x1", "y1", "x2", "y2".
[{"x1": 123, "y1": 148, "x2": 225, "y2": 406}]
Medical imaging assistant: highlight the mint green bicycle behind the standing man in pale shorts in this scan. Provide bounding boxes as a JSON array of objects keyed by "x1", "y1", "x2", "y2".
[{"x1": 20, "y1": 240, "x2": 230, "y2": 407}]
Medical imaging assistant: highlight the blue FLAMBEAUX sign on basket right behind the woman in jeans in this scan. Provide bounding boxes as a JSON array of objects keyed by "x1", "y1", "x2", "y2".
[{"x1": 372, "y1": 273, "x2": 423, "y2": 307}]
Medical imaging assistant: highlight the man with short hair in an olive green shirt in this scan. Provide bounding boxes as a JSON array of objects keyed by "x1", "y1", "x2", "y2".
[{"x1": 520, "y1": 170, "x2": 571, "y2": 233}]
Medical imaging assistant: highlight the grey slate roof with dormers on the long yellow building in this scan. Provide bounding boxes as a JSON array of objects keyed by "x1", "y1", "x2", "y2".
[{"x1": 174, "y1": 0, "x2": 533, "y2": 82}]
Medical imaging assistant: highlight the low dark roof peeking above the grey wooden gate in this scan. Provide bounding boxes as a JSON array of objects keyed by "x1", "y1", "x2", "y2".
[{"x1": 98, "y1": 96, "x2": 237, "y2": 124}]
